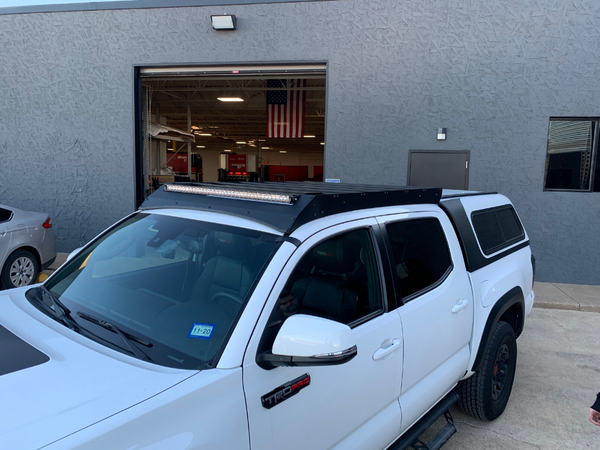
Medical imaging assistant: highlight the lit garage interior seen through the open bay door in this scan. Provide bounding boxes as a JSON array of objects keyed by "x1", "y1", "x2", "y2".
[{"x1": 140, "y1": 65, "x2": 326, "y2": 194}]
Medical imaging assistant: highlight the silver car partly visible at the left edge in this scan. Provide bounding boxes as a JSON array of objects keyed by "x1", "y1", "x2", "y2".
[{"x1": 0, "y1": 204, "x2": 56, "y2": 289}]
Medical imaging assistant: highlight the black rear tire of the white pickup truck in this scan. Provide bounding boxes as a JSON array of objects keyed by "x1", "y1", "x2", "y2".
[{"x1": 458, "y1": 322, "x2": 517, "y2": 421}]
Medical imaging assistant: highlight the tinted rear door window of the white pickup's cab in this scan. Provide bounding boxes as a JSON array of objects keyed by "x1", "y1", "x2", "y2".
[{"x1": 386, "y1": 219, "x2": 452, "y2": 301}]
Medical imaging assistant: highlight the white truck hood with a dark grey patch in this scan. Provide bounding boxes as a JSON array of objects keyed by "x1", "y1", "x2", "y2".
[{"x1": 0, "y1": 286, "x2": 197, "y2": 449}]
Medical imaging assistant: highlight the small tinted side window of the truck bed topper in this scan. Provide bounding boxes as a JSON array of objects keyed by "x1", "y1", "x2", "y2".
[{"x1": 471, "y1": 205, "x2": 525, "y2": 255}]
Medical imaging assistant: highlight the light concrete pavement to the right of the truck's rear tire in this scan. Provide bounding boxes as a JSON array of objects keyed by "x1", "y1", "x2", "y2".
[{"x1": 424, "y1": 308, "x2": 600, "y2": 450}]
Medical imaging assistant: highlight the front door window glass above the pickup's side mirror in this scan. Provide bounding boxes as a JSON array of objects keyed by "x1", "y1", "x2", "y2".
[{"x1": 259, "y1": 229, "x2": 382, "y2": 353}]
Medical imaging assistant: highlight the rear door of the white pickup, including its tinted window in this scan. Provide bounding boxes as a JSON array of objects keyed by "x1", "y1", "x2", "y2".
[{"x1": 380, "y1": 211, "x2": 473, "y2": 431}]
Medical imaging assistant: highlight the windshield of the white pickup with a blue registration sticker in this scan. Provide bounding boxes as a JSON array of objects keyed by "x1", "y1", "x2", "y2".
[{"x1": 36, "y1": 213, "x2": 278, "y2": 369}]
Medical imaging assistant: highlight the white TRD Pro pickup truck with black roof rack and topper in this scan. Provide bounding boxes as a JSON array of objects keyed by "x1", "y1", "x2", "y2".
[{"x1": 0, "y1": 183, "x2": 535, "y2": 450}]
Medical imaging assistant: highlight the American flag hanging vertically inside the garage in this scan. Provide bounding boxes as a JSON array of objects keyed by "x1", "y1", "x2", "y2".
[{"x1": 267, "y1": 80, "x2": 306, "y2": 138}]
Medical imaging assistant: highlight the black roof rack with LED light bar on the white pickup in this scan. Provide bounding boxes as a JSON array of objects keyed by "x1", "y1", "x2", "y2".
[{"x1": 140, "y1": 181, "x2": 442, "y2": 234}]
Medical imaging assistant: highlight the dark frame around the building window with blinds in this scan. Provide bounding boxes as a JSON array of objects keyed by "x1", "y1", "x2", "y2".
[{"x1": 543, "y1": 117, "x2": 600, "y2": 193}]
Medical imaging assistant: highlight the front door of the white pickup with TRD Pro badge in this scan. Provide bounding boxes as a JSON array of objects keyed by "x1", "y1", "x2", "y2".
[{"x1": 243, "y1": 219, "x2": 403, "y2": 450}]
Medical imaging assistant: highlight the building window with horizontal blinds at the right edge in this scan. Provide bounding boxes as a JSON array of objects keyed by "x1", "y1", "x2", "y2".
[{"x1": 544, "y1": 118, "x2": 600, "y2": 192}]
